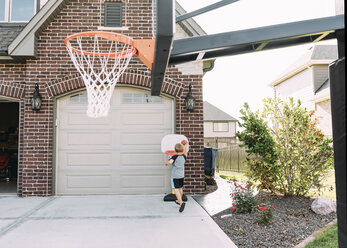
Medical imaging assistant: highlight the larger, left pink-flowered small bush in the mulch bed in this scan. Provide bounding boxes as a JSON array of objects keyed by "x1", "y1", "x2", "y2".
[{"x1": 231, "y1": 182, "x2": 257, "y2": 213}]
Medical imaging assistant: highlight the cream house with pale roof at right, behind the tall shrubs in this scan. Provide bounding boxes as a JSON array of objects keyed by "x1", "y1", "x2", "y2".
[{"x1": 271, "y1": 45, "x2": 338, "y2": 137}]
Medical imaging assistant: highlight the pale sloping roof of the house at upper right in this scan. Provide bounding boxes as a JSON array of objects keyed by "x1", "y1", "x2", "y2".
[{"x1": 270, "y1": 45, "x2": 338, "y2": 87}]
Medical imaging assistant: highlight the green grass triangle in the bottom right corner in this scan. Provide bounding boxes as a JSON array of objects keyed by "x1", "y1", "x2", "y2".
[{"x1": 305, "y1": 223, "x2": 338, "y2": 248}]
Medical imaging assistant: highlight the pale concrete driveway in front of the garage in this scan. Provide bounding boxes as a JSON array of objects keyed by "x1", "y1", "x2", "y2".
[{"x1": 0, "y1": 195, "x2": 236, "y2": 248}]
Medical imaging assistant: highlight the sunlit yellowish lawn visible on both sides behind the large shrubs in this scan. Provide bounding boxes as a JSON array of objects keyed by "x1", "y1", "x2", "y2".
[{"x1": 216, "y1": 170, "x2": 336, "y2": 201}]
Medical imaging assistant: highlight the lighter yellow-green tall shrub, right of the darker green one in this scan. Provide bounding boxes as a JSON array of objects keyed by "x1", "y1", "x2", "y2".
[{"x1": 263, "y1": 98, "x2": 333, "y2": 196}]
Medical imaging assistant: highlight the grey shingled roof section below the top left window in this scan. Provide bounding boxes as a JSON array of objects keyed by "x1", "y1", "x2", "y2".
[{"x1": 0, "y1": 23, "x2": 26, "y2": 55}]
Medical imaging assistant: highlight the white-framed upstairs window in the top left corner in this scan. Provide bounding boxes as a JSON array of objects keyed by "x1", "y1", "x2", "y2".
[{"x1": 0, "y1": 0, "x2": 39, "y2": 22}]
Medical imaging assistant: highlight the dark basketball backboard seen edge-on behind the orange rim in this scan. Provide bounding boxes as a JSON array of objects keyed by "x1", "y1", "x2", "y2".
[{"x1": 151, "y1": 0, "x2": 175, "y2": 96}]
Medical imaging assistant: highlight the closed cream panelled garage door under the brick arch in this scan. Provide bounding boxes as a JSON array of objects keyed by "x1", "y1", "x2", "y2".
[{"x1": 56, "y1": 87, "x2": 174, "y2": 195}]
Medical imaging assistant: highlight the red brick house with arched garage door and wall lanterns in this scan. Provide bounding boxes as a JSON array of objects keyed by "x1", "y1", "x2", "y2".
[{"x1": 0, "y1": 0, "x2": 213, "y2": 196}]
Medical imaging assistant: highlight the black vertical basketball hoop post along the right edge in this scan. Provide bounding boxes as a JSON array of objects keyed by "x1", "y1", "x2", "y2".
[{"x1": 329, "y1": 0, "x2": 347, "y2": 248}]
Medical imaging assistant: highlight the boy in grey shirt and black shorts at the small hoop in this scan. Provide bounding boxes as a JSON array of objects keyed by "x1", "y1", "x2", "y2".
[{"x1": 165, "y1": 140, "x2": 188, "y2": 212}]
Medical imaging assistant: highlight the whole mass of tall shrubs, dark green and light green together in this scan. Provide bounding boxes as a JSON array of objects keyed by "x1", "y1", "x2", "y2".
[{"x1": 237, "y1": 98, "x2": 333, "y2": 196}]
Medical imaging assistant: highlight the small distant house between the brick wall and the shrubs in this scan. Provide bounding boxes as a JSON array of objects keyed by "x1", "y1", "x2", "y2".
[{"x1": 204, "y1": 101, "x2": 237, "y2": 148}]
